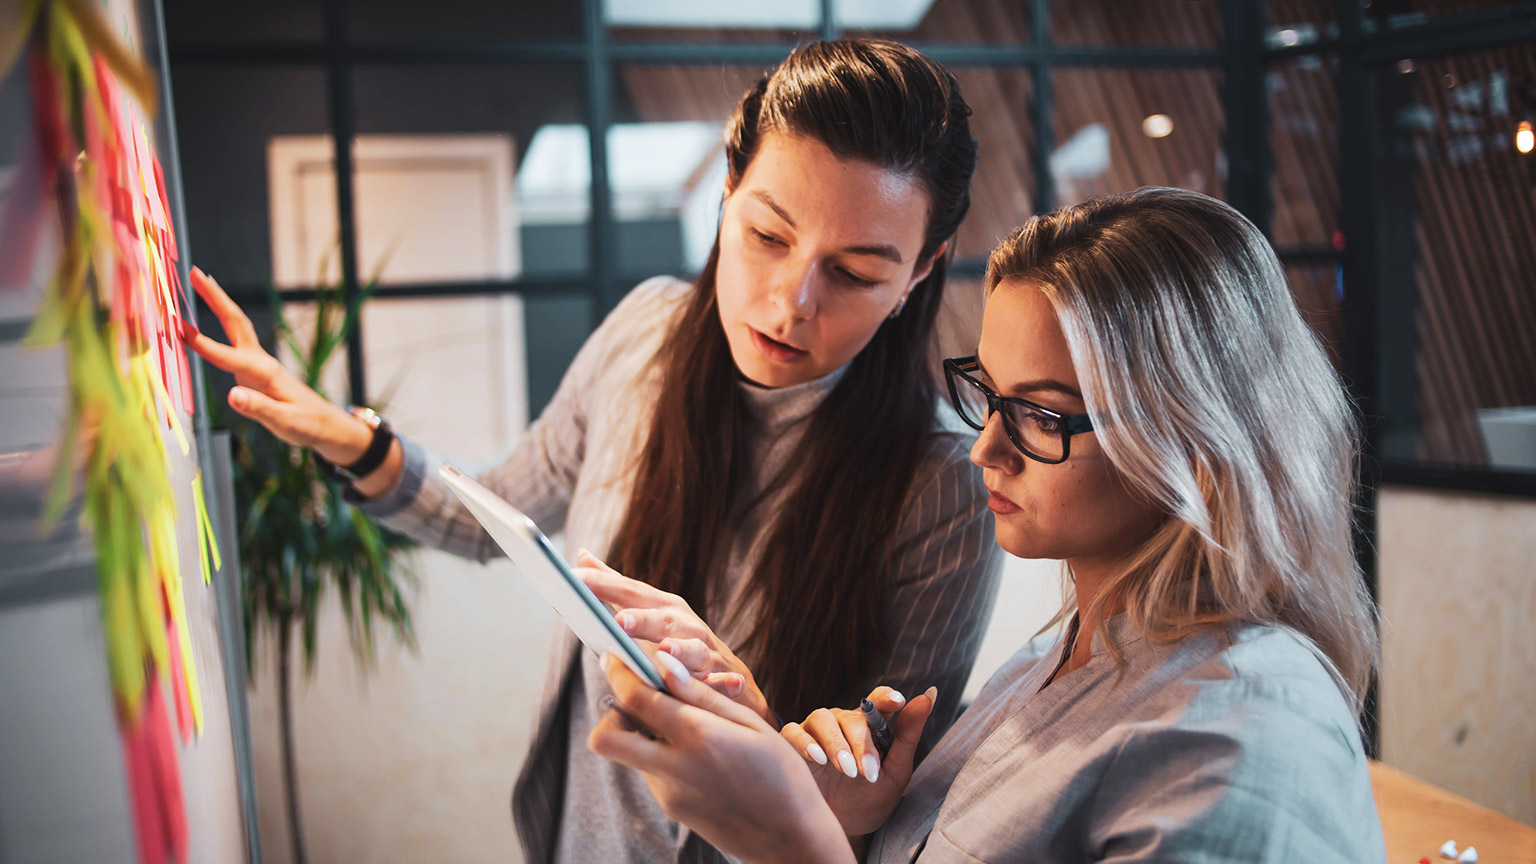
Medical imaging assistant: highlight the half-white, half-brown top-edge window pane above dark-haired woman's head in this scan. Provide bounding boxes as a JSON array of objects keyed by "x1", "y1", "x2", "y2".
[{"x1": 836, "y1": 0, "x2": 1034, "y2": 45}]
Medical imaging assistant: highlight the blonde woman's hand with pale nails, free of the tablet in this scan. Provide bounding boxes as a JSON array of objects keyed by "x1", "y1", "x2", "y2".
[{"x1": 780, "y1": 687, "x2": 938, "y2": 836}]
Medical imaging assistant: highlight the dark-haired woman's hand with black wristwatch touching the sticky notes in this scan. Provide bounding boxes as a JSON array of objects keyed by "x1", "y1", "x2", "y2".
[{"x1": 181, "y1": 268, "x2": 399, "y2": 493}]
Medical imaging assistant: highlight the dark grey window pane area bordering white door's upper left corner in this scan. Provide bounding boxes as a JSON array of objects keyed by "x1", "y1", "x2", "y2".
[{"x1": 170, "y1": 63, "x2": 330, "y2": 285}]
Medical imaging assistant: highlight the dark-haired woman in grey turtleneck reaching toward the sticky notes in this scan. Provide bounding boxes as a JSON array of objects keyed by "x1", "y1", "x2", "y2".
[{"x1": 192, "y1": 40, "x2": 998, "y2": 861}]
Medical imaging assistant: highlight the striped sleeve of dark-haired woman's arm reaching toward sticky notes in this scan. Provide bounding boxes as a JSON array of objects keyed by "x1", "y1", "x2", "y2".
[{"x1": 358, "y1": 277, "x2": 674, "y2": 561}]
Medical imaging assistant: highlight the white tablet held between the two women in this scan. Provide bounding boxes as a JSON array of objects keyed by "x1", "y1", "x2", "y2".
[{"x1": 438, "y1": 464, "x2": 667, "y2": 693}]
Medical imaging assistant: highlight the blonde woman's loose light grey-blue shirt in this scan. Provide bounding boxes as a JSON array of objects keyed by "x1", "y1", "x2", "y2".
[{"x1": 868, "y1": 615, "x2": 1385, "y2": 864}]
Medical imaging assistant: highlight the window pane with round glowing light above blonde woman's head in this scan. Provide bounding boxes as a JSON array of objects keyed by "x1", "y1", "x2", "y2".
[{"x1": 1051, "y1": 69, "x2": 1226, "y2": 204}]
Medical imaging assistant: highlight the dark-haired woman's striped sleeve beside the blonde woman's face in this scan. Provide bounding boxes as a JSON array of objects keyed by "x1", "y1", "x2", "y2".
[{"x1": 863, "y1": 432, "x2": 1003, "y2": 753}]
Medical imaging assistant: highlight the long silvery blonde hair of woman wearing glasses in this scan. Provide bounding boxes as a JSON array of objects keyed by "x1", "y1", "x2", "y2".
[{"x1": 986, "y1": 188, "x2": 1378, "y2": 716}]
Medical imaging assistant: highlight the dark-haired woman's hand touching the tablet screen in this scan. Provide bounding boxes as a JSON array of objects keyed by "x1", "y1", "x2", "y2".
[{"x1": 576, "y1": 549, "x2": 776, "y2": 724}]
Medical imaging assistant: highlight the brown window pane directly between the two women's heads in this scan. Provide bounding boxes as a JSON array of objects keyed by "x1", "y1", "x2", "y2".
[{"x1": 954, "y1": 69, "x2": 1037, "y2": 260}]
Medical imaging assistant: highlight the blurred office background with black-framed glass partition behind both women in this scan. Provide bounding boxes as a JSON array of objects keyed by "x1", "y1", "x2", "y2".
[{"x1": 12, "y1": 0, "x2": 1536, "y2": 862}]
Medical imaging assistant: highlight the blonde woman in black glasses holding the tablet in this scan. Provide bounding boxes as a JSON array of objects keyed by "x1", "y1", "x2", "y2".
[{"x1": 590, "y1": 189, "x2": 1385, "y2": 862}]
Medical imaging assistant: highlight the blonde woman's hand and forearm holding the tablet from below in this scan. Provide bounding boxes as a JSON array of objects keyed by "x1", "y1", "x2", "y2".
[{"x1": 587, "y1": 642, "x2": 854, "y2": 864}]
